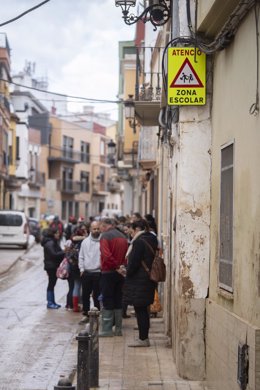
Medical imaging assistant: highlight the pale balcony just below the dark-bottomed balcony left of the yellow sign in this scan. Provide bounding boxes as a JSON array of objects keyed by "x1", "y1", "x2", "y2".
[{"x1": 138, "y1": 127, "x2": 158, "y2": 170}]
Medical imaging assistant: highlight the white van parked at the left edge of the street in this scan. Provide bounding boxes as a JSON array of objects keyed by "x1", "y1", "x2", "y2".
[{"x1": 0, "y1": 210, "x2": 30, "y2": 249}]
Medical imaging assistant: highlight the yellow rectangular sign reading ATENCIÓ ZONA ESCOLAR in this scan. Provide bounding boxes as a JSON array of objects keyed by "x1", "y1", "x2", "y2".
[{"x1": 167, "y1": 47, "x2": 206, "y2": 106}]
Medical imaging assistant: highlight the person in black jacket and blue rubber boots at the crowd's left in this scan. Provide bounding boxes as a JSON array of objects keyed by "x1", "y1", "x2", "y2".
[{"x1": 41, "y1": 228, "x2": 64, "y2": 309}]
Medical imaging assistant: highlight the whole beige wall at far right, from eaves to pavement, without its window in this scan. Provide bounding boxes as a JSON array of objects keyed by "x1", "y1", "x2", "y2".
[{"x1": 206, "y1": 11, "x2": 260, "y2": 390}]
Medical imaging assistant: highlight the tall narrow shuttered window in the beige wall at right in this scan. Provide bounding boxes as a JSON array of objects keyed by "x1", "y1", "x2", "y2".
[{"x1": 219, "y1": 144, "x2": 233, "y2": 292}]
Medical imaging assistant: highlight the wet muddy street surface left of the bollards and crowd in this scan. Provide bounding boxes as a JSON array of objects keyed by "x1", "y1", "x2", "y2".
[{"x1": 0, "y1": 244, "x2": 81, "y2": 390}]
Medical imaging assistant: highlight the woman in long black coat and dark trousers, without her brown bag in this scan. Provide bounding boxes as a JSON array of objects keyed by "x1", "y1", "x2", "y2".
[{"x1": 123, "y1": 219, "x2": 158, "y2": 347}]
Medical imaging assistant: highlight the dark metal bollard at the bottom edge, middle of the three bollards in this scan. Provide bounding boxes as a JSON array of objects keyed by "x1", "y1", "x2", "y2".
[{"x1": 76, "y1": 330, "x2": 91, "y2": 390}]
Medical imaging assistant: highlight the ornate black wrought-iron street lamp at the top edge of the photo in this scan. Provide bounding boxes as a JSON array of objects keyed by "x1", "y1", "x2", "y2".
[{"x1": 115, "y1": 0, "x2": 171, "y2": 30}]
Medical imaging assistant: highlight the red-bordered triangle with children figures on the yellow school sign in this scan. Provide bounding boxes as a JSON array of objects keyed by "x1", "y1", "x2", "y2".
[{"x1": 170, "y1": 58, "x2": 203, "y2": 88}]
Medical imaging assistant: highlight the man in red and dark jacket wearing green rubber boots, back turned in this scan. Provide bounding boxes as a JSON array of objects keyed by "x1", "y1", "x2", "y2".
[{"x1": 99, "y1": 218, "x2": 128, "y2": 337}]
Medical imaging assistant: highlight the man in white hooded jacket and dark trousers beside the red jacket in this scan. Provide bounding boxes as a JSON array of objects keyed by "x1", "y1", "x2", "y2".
[{"x1": 79, "y1": 221, "x2": 101, "y2": 323}]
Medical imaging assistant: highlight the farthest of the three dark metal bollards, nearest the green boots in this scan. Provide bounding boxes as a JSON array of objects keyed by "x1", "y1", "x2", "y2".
[{"x1": 88, "y1": 307, "x2": 99, "y2": 387}]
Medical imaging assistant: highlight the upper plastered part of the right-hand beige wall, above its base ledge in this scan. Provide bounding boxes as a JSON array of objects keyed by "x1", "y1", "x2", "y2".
[{"x1": 210, "y1": 9, "x2": 260, "y2": 326}]
